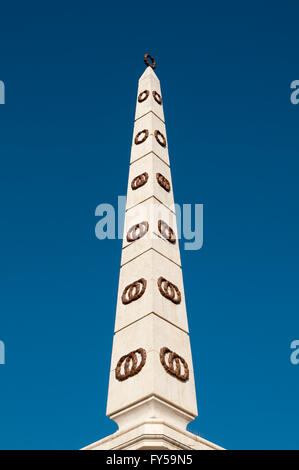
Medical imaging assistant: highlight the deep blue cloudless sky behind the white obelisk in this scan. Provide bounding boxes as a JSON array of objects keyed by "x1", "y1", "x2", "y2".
[{"x1": 0, "y1": 0, "x2": 299, "y2": 449}]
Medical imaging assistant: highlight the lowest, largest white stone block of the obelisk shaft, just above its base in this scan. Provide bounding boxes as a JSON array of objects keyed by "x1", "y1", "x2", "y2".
[{"x1": 107, "y1": 314, "x2": 197, "y2": 416}]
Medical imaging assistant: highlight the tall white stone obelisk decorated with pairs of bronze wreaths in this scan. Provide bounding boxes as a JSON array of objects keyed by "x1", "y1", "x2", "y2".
[{"x1": 85, "y1": 58, "x2": 223, "y2": 450}]
